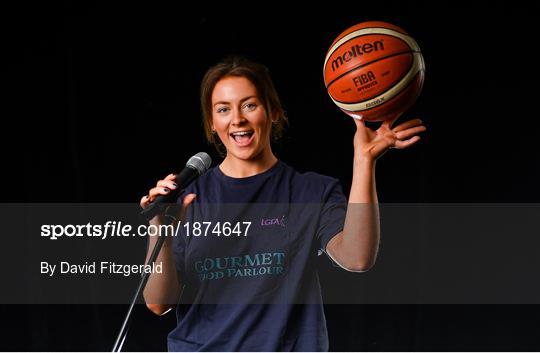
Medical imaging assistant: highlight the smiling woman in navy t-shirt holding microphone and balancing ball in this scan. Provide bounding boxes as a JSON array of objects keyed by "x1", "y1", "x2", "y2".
[{"x1": 141, "y1": 58, "x2": 425, "y2": 351}]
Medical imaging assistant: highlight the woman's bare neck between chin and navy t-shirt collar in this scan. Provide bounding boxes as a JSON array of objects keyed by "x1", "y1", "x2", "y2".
[{"x1": 219, "y1": 148, "x2": 277, "y2": 178}]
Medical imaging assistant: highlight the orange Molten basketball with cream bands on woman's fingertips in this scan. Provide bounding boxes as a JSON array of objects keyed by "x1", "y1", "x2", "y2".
[{"x1": 324, "y1": 21, "x2": 425, "y2": 121}]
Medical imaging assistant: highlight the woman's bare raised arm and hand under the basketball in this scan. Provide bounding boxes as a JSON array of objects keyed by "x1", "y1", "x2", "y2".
[{"x1": 326, "y1": 116, "x2": 426, "y2": 272}]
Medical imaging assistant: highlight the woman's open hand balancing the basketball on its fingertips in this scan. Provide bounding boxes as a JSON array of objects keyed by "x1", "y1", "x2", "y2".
[{"x1": 353, "y1": 115, "x2": 426, "y2": 160}]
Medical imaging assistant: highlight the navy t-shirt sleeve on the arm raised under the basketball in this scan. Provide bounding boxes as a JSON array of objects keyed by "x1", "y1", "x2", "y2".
[{"x1": 317, "y1": 179, "x2": 347, "y2": 255}]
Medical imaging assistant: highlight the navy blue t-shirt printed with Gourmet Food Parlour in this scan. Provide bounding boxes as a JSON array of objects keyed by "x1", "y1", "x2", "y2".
[{"x1": 168, "y1": 161, "x2": 347, "y2": 351}]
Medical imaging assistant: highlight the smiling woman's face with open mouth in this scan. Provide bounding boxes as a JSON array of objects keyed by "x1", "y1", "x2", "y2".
[{"x1": 212, "y1": 76, "x2": 272, "y2": 160}]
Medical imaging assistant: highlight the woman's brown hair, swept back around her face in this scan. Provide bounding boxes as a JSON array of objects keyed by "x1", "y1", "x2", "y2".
[{"x1": 201, "y1": 56, "x2": 287, "y2": 154}]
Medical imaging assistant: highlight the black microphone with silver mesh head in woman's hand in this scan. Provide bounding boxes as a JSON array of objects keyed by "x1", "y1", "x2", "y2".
[{"x1": 141, "y1": 152, "x2": 212, "y2": 220}]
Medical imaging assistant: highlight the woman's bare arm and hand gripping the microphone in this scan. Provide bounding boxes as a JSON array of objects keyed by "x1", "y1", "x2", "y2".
[{"x1": 141, "y1": 174, "x2": 195, "y2": 315}]
